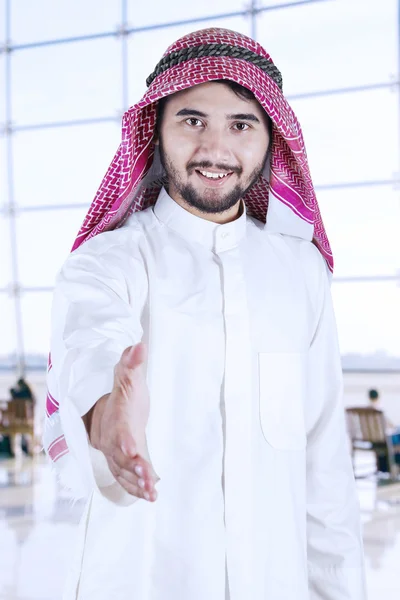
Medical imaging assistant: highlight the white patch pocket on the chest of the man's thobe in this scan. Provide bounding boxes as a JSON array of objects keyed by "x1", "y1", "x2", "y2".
[{"x1": 258, "y1": 352, "x2": 306, "y2": 450}]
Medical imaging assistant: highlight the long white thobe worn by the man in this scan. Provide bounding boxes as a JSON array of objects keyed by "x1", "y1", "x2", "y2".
[{"x1": 51, "y1": 190, "x2": 366, "y2": 600}]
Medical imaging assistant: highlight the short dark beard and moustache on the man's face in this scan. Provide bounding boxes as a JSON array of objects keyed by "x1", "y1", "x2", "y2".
[{"x1": 159, "y1": 139, "x2": 268, "y2": 214}]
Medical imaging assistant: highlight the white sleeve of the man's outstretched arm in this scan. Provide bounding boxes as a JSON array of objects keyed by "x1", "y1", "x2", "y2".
[{"x1": 48, "y1": 234, "x2": 147, "y2": 504}]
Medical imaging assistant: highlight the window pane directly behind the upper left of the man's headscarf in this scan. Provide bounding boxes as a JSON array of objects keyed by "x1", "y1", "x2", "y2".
[{"x1": 128, "y1": 16, "x2": 250, "y2": 104}]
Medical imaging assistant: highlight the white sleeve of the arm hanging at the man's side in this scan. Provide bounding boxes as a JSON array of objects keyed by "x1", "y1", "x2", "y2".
[{"x1": 307, "y1": 260, "x2": 367, "y2": 600}]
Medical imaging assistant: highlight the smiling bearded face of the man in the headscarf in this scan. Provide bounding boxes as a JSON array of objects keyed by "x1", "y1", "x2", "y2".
[{"x1": 159, "y1": 82, "x2": 269, "y2": 214}]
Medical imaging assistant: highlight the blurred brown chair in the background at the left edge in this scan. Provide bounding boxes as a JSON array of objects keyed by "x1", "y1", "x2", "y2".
[{"x1": 0, "y1": 398, "x2": 35, "y2": 456}]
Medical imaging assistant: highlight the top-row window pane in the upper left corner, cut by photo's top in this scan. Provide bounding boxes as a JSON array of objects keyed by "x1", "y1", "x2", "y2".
[{"x1": 11, "y1": 0, "x2": 121, "y2": 44}]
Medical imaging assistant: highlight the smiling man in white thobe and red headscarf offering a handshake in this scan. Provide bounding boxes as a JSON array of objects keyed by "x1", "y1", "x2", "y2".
[{"x1": 45, "y1": 29, "x2": 365, "y2": 600}]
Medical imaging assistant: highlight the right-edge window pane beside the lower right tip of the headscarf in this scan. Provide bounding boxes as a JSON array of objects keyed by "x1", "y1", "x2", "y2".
[{"x1": 317, "y1": 186, "x2": 400, "y2": 277}]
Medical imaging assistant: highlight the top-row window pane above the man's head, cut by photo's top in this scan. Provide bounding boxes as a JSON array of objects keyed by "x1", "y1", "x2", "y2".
[{"x1": 128, "y1": 0, "x2": 246, "y2": 28}]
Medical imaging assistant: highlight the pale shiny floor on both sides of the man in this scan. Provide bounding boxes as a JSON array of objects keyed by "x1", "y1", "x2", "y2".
[{"x1": 0, "y1": 453, "x2": 400, "y2": 600}]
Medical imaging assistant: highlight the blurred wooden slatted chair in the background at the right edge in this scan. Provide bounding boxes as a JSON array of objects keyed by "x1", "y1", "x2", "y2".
[{"x1": 346, "y1": 407, "x2": 400, "y2": 479}]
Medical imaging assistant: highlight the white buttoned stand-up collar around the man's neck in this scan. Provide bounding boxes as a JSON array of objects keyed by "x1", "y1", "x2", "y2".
[{"x1": 153, "y1": 188, "x2": 246, "y2": 253}]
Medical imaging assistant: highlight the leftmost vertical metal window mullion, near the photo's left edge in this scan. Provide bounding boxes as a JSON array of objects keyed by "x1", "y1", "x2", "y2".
[{"x1": 5, "y1": 0, "x2": 25, "y2": 375}]
